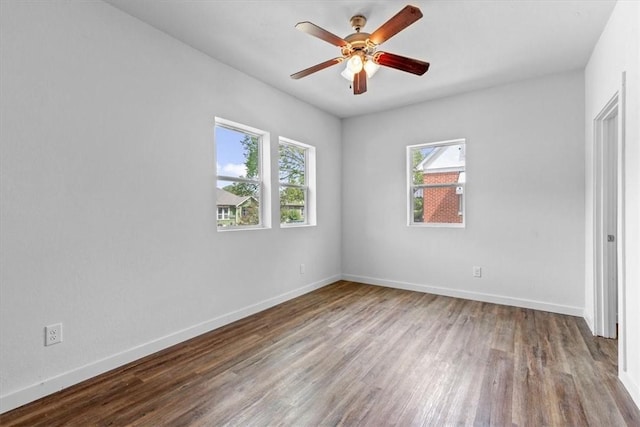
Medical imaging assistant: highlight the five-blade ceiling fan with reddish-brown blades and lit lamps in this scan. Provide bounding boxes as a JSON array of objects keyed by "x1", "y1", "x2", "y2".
[{"x1": 291, "y1": 6, "x2": 429, "y2": 95}]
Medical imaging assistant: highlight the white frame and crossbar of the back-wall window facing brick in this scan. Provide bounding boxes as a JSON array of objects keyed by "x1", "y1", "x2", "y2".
[{"x1": 406, "y1": 138, "x2": 468, "y2": 228}]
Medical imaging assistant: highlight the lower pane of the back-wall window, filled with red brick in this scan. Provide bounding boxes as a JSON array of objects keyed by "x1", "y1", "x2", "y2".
[{"x1": 414, "y1": 186, "x2": 464, "y2": 224}]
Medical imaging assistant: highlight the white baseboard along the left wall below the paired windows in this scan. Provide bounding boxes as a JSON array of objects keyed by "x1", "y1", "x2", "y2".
[{"x1": 0, "y1": 275, "x2": 341, "y2": 414}]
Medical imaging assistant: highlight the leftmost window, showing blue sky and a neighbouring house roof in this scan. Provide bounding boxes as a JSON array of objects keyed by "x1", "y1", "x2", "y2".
[{"x1": 214, "y1": 118, "x2": 271, "y2": 230}]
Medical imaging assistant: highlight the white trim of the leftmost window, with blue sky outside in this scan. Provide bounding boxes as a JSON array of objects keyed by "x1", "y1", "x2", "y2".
[{"x1": 213, "y1": 116, "x2": 271, "y2": 232}]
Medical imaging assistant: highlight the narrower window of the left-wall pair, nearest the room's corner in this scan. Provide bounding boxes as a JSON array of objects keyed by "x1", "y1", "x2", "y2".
[{"x1": 278, "y1": 138, "x2": 315, "y2": 226}]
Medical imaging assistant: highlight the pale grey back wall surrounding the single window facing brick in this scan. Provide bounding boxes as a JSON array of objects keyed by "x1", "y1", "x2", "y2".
[{"x1": 342, "y1": 71, "x2": 584, "y2": 315}]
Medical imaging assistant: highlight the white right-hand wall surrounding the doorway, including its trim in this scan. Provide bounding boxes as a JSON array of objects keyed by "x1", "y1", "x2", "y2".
[{"x1": 585, "y1": 0, "x2": 640, "y2": 406}]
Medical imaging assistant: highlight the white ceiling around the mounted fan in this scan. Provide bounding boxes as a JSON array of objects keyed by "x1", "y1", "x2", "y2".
[{"x1": 106, "y1": 0, "x2": 615, "y2": 117}]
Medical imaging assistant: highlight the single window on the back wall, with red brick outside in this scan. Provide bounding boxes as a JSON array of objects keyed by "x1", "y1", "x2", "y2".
[{"x1": 407, "y1": 139, "x2": 466, "y2": 227}]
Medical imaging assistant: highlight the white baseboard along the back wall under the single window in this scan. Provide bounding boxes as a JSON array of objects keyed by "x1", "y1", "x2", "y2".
[{"x1": 342, "y1": 274, "x2": 584, "y2": 317}]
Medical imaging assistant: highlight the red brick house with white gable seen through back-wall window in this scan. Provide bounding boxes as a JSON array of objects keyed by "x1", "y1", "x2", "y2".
[{"x1": 416, "y1": 144, "x2": 465, "y2": 224}]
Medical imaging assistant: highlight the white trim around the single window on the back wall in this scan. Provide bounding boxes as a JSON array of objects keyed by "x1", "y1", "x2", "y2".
[{"x1": 406, "y1": 138, "x2": 469, "y2": 228}]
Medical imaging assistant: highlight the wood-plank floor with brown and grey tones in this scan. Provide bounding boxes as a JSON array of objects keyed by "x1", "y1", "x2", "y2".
[{"x1": 0, "y1": 281, "x2": 640, "y2": 426}]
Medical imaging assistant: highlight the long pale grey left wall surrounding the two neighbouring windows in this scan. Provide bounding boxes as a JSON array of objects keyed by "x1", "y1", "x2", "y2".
[{"x1": 0, "y1": 0, "x2": 341, "y2": 411}]
